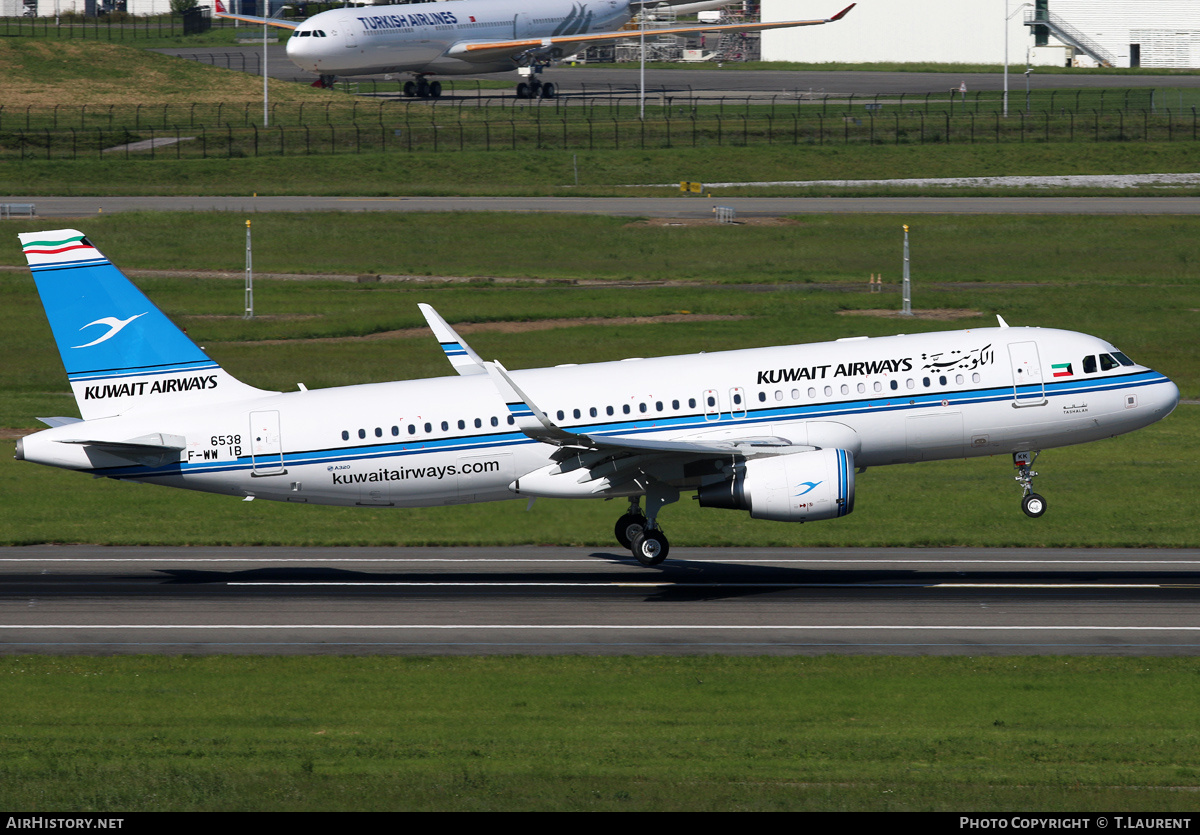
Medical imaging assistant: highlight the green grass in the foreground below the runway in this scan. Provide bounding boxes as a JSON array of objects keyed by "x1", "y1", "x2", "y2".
[{"x1": 7, "y1": 657, "x2": 1200, "y2": 812}]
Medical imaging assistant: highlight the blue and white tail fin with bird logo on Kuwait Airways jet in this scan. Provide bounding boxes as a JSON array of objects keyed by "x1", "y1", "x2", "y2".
[{"x1": 19, "y1": 229, "x2": 268, "y2": 420}]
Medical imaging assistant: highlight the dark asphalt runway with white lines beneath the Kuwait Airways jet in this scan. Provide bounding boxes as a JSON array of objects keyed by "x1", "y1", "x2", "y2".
[{"x1": 0, "y1": 546, "x2": 1200, "y2": 655}]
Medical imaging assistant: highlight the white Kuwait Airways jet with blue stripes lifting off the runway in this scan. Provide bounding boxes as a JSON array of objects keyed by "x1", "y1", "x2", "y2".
[{"x1": 17, "y1": 229, "x2": 1180, "y2": 565}]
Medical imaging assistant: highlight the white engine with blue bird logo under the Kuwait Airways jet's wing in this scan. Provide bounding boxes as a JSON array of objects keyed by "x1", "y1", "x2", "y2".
[{"x1": 697, "y1": 450, "x2": 854, "y2": 522}]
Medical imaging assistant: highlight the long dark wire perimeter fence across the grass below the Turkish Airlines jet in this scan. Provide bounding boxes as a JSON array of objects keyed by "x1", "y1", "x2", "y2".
[{"x1": 0, "y1": 91, "x2": 1200, "y2": 160}]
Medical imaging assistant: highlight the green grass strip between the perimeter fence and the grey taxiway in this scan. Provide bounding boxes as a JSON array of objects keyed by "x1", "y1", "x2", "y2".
[{"x1": 9, "y1": 143, "x2": 1195, "y2": 196}]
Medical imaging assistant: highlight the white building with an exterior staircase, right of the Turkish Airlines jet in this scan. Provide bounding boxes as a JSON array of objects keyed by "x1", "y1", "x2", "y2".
[{"x1": 762, "y1": 0, "x2": 1200, "y2": 68}]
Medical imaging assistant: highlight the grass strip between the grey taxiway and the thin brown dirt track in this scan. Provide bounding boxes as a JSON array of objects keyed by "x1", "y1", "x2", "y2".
[{"x1": 7, "y1": 209, "x2": 1200, "y2": 289}]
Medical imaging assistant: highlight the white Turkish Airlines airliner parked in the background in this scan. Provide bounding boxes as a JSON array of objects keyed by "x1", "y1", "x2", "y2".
[{"x1": 217, "y1": 0, "x2": 856, "y2": 98}]
